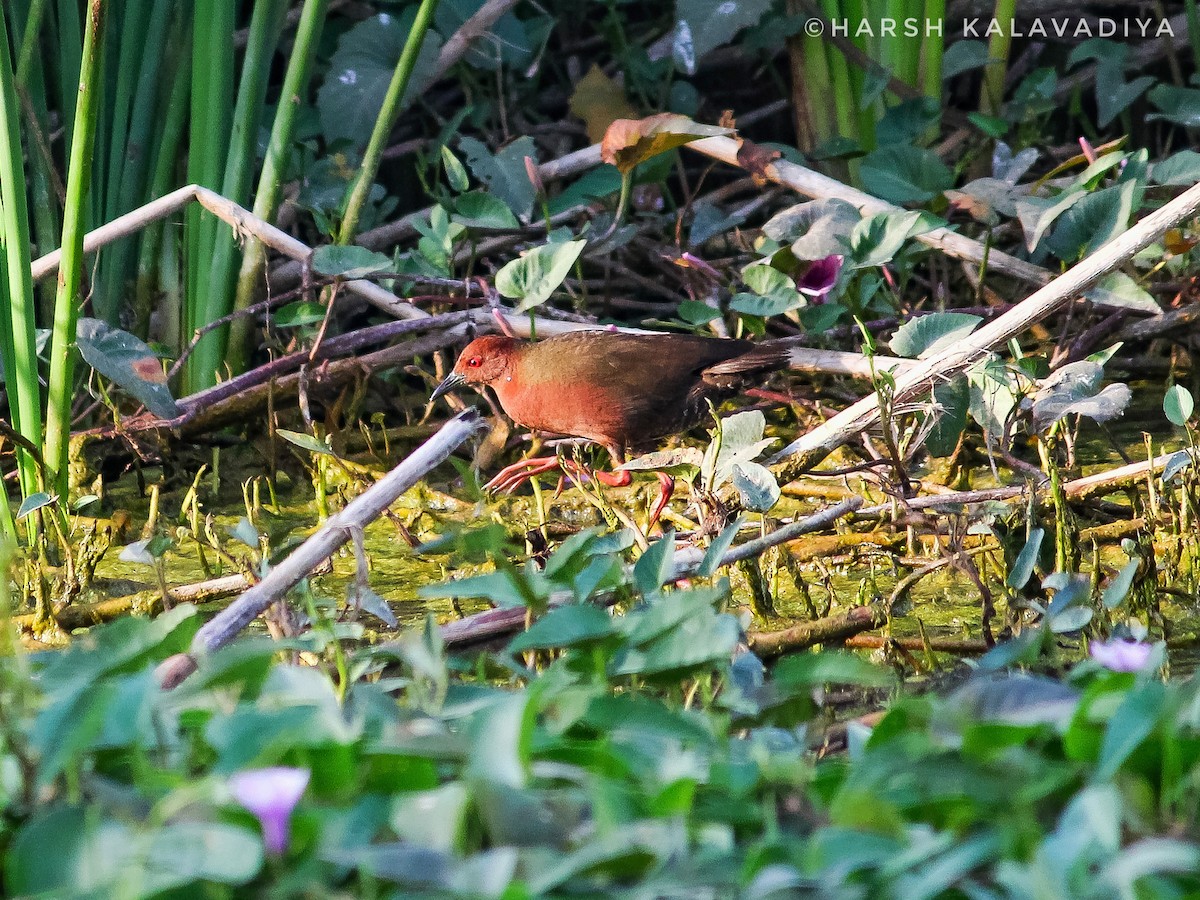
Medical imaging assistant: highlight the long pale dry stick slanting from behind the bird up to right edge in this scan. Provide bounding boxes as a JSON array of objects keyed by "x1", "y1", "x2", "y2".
[{"x1": 758, "y1": 180, "x2": 1200, "y2": 481}]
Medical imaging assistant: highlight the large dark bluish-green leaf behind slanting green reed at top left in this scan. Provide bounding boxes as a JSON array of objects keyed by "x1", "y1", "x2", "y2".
[{"x1": 317, "y1": 12, "x2": 442, "y2": 148}]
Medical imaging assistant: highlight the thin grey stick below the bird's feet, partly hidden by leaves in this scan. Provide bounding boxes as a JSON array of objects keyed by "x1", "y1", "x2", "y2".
[{"x1": 440, "y1": 497, "x2": 863, "y2": 647}]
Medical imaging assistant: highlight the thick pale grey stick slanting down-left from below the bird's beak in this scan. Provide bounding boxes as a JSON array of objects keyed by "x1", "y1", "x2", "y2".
[{"x1": 157, "y1": 408, "x2": 485, "y2": 689}]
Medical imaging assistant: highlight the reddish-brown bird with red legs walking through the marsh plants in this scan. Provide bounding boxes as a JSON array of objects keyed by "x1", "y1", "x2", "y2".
[{"x1": 430, "y1": 329, "x2": 791, "y2": 522}]
